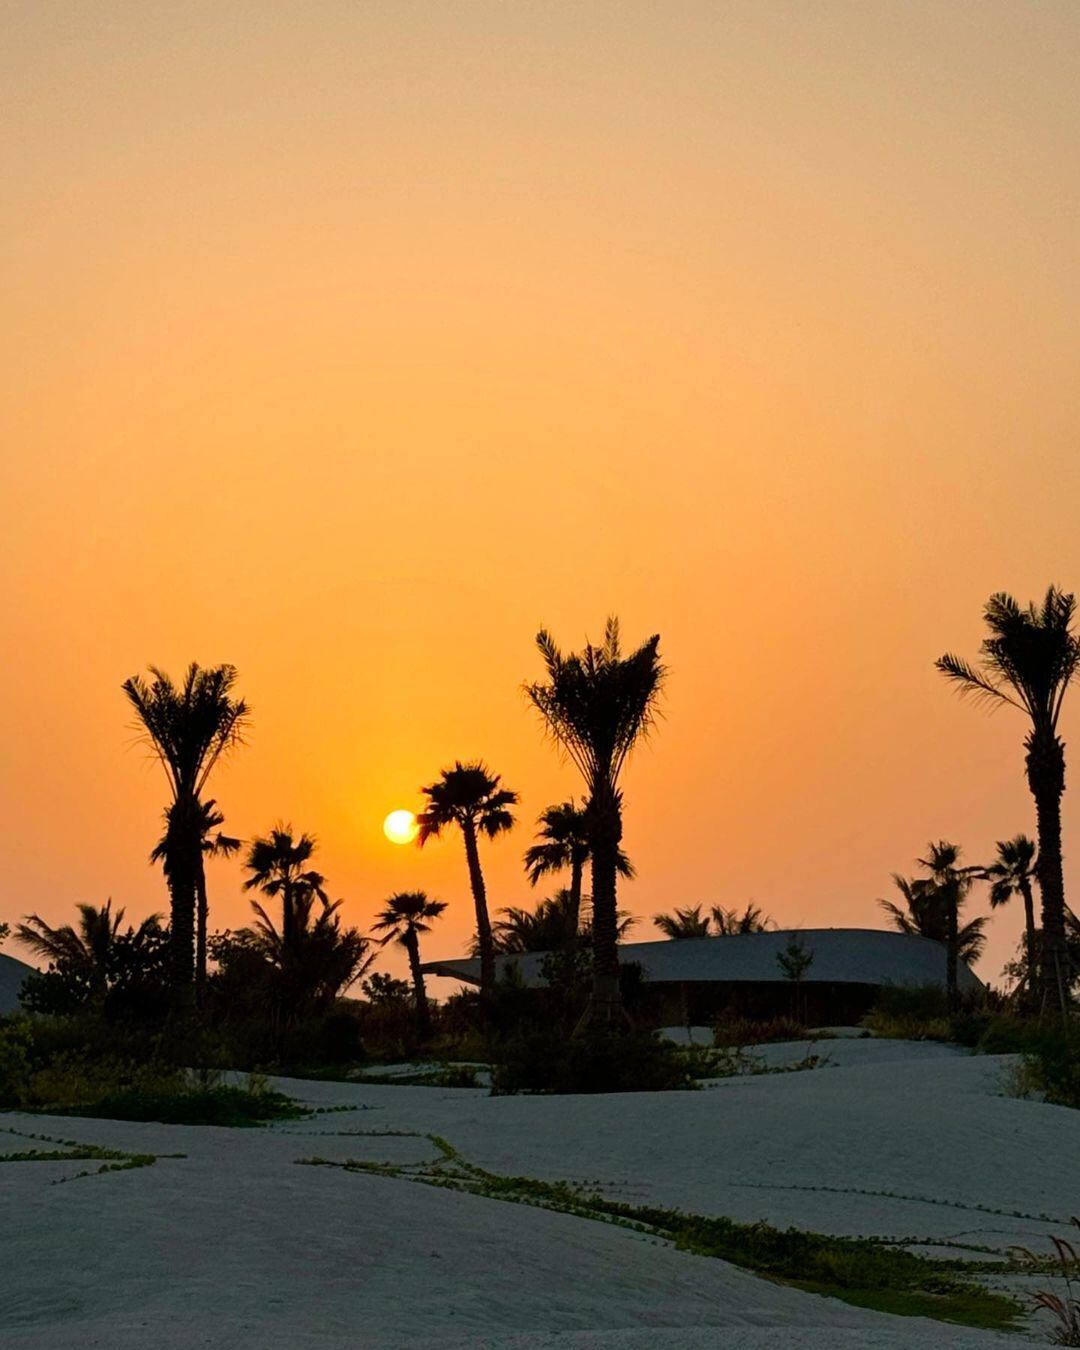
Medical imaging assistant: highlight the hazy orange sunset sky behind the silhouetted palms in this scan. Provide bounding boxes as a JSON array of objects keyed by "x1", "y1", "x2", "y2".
[{"x1": 0, "y1": 0, "x2": 1080, "y2": 979}]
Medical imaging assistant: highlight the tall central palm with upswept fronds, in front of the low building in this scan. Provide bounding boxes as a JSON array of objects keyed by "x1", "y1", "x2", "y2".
[{"x1": 525, "y1": 618, "x2": 666, "y2": 1026}]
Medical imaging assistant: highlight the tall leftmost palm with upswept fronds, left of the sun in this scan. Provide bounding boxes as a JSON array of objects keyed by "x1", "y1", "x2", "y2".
[{"x1": 123, "y1": 662, "x2": 248, "y2": 1004}]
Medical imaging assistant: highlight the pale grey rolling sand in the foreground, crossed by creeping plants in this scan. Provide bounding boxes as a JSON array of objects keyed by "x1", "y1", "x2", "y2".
[{"x1": 0, "y1": 1041, "x2": 1080, "y2": 1350}]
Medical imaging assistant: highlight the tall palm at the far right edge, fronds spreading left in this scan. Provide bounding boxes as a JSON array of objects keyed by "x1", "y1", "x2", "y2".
[{"x1": 937, "y1": 586, "x2": 1080, "y2": 1015}]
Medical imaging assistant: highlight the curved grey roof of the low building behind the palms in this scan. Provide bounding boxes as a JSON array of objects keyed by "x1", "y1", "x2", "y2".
[{"x1": 423, "y1": 929, "x2": 983, "y2": 990}]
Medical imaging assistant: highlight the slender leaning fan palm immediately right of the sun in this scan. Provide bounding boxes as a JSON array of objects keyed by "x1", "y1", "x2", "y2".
[{"x1": 416, "y1": 760, "x2": 517, "y2": 998}]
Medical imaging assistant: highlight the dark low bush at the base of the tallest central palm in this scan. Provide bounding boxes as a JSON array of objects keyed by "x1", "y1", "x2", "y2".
[{"x1": 491, "y1": 1031, "x2": 694, "y2": 1096}]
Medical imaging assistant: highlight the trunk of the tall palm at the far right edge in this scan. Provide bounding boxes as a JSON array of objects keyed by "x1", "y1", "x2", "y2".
[{"x1": 1027, "y1": 732, "x2": 1069, "y2": 1017}]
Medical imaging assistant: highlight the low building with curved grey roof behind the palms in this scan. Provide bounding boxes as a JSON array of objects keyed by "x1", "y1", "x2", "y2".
[{"x1": 423, "y1": 929, "x2": 983, "y2": 1026}]
